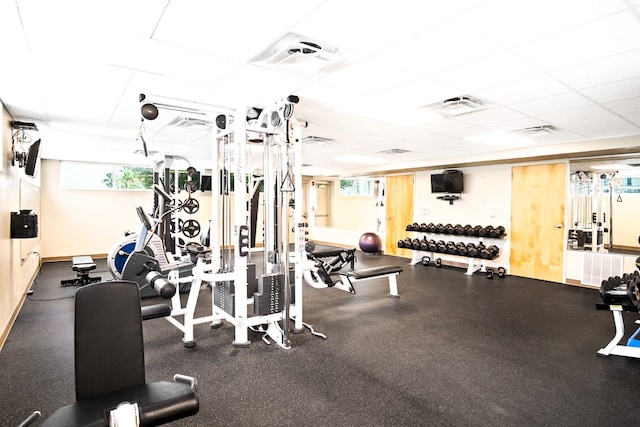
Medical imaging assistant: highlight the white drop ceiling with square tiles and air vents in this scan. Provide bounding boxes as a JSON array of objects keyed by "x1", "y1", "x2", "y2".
[{"x1": 0, "y1": 0, "x2": 640, "y2": 176}]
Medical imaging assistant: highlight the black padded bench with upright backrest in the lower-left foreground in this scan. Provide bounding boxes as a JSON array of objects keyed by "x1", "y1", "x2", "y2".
[{"x1": 43, "y1": 281, "x2": 199, "y2": 427}]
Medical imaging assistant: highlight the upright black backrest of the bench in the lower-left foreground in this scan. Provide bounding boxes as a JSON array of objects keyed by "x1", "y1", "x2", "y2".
[{"x1": 74, "y1": 281, "x2": 145, "y2": 402}]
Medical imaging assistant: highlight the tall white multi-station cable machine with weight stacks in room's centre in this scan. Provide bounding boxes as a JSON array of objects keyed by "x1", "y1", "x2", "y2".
[{"x1": 167, "y1": 96, "x2": 314, "y2": 348}]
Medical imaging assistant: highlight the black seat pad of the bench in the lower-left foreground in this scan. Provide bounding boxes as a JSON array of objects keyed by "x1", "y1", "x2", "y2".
[{"x1": 42, "y1": 381, "x2": 199, "y2": 427}]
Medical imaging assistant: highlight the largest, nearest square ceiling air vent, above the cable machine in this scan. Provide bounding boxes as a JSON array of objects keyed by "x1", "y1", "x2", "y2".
[{"x1": 250, "y1": 33, "x2": 345, "y2": 77}]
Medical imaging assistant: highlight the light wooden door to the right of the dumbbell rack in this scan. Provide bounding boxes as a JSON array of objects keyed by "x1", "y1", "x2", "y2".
[{"x1": 510, "y1": 163, "x2": 567, "y2": 283}]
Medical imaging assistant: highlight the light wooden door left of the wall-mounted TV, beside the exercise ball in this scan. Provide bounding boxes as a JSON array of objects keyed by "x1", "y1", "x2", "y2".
[{"x1": 385, "y1": 174, "x2": 415, "y2": 258}]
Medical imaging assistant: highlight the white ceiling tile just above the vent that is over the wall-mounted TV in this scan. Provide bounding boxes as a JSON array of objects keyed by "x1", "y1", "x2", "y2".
[{"x1": 431, "y1": 52, "x2": 540, "y2": 92}]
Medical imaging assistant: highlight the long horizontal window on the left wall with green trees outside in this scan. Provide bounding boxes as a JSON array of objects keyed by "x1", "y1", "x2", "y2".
[{"x1": 60, "y1": 162, "x2": 153, "y2": 190}]
